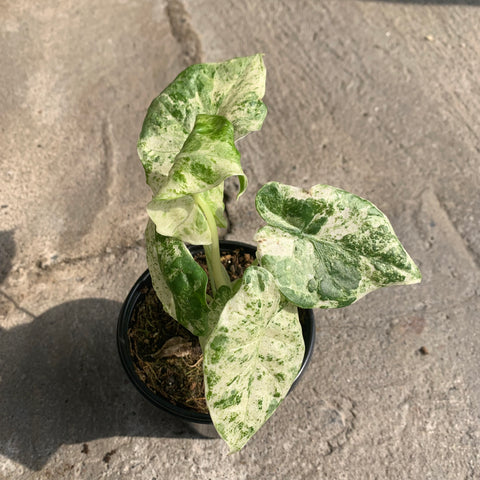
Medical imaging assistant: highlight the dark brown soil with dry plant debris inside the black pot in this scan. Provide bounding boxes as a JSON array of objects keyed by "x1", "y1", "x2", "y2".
[{"x1": 128, "y1": 250, "x2": 255, "y2": 413}]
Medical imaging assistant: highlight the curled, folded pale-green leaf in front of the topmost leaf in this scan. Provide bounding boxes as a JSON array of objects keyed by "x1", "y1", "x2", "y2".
[{"x1": 147, "y1": 115, "x2": 247, "y2": 245}]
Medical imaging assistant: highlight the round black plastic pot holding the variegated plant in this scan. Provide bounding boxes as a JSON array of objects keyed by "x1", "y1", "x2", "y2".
[{"x1": 117, "y1": 240, "x2": 315, "y2": 437}]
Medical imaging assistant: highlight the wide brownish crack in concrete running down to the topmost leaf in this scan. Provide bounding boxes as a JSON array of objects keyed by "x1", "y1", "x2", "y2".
[{"x1": 166, "y1": 0, "x2": 203, "y2": 66}]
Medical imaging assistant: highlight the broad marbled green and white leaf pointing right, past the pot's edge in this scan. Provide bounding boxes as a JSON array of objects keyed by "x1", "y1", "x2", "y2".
[{"x1": 256, "y1": 182, "x2": 421, "y2": 308}]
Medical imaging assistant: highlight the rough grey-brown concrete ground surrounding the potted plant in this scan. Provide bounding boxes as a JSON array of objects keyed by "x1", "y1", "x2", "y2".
[{"x1": 0, "y1": 0, "x2": 480, "y2": 480}]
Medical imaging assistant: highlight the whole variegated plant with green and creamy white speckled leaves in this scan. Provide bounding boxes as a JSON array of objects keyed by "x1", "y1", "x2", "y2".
[{"x1": 138, "y1": 55, "x2": 421, "y2": 451}]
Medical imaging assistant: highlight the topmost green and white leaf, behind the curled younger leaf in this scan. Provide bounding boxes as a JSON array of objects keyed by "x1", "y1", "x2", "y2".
[{"x1": 137, "y1": 55, "x2": 267, "y2": 195}]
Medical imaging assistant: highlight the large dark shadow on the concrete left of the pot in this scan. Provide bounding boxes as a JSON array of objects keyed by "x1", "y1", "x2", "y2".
[{"x1": 0, "y1": 299, "x2": 207, "y2": 470}]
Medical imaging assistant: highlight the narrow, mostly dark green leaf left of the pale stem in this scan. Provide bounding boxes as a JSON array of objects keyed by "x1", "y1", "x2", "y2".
[{"x1": 145, "y1": 221, "x2": 209, "y2": 336}]
